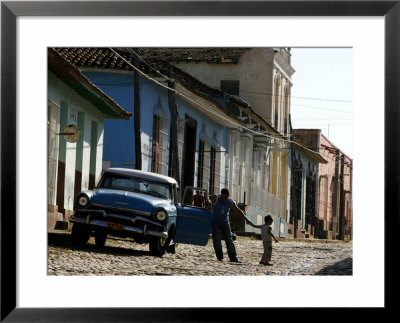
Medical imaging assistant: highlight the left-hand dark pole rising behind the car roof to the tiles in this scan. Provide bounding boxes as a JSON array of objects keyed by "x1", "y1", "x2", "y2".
[{"x1": 133, "y1": 48, "x2": 142, "y2": 170}]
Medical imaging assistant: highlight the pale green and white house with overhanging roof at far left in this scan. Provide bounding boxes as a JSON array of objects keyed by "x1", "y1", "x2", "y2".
[{"x1": 47, "y1": 48, "x2": 131, "y2": 230}]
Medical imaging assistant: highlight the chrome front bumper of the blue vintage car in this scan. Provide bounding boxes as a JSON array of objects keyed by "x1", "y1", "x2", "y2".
[{"x1": 69, "y1": 215, "x2": 168, "y2": 238}]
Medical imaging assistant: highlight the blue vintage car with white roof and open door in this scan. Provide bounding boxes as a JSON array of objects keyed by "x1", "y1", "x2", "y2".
[{"x1": 70, "y1": 168, "x2": 211, "y2": 257}]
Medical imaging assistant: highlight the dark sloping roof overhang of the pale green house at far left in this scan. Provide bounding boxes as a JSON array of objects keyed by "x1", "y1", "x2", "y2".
[{"x1": 47, "y1": 48, "x2": 132, "y2": 119}]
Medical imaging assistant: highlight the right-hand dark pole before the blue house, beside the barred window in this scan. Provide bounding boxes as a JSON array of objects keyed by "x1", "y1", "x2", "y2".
[{"x1": 168, "y1": 65, "x2": 180, "y2": 185}]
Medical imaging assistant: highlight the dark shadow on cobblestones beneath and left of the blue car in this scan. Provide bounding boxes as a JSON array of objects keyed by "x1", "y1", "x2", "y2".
[{"x1": 47, "y1": 232, "x2": 150, "y2": 257}]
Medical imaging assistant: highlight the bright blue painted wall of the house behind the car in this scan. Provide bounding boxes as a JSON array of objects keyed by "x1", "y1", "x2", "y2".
[{"x1": 84, "y1": 71, "x2": 229, "y2": 192}]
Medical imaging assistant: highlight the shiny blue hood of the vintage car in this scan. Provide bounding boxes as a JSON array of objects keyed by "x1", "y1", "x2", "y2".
[{"x1": 90, "y1": 188, "x2": 171, "y2": 213}]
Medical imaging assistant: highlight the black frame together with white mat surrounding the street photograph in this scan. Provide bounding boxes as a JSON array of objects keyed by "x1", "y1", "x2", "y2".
[{"x1": 0, "y1": 0, "x2": 400, "y2": 322}]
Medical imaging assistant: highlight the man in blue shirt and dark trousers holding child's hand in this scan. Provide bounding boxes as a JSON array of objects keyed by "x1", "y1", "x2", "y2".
[{"x1": 209, "y1": 188, "x2": 248, "y2": 262}]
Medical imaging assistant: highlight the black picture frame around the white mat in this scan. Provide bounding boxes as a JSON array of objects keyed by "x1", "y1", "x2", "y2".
[{"x1": 0, "y1": 0, "x2": 400, "y2": 322}]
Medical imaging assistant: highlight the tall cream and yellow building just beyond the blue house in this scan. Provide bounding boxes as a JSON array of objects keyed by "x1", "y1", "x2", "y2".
[{"x1": 139, "y1": 48, "x2": 294, "y2": 232}]
